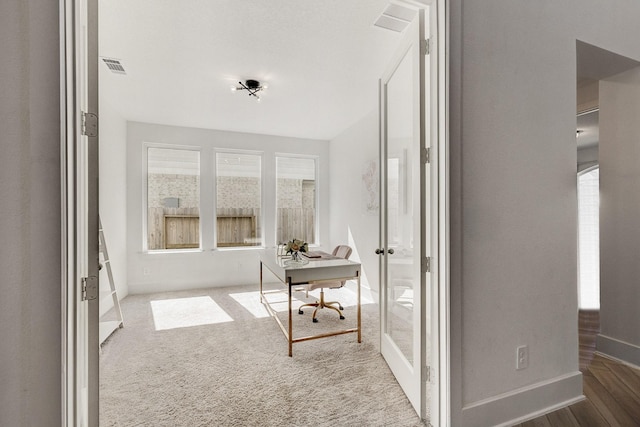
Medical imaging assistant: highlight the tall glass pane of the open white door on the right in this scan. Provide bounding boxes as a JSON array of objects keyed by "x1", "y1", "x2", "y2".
[{"x1": 386, "y1": 43, "x2": 419, "y2": 363}]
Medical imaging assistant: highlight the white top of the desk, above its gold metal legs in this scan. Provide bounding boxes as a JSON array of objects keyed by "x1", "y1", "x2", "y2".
[{"x1": 260, "y1": 249, "x2": 360, "y2": 285}]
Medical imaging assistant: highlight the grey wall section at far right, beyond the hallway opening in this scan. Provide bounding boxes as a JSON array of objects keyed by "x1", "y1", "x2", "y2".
[{"x1": 597, "y1": 67, "x2": 640, "y2": 366}]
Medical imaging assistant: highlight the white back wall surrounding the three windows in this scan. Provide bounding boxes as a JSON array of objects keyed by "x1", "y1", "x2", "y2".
[{"x1": 127, "y1": 122, "x2": 331, "y2": 294}]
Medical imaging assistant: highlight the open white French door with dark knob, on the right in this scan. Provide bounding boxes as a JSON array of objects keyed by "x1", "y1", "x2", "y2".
[{"x1": 376, "y1": 4, "x2": 439, "y2": 425}]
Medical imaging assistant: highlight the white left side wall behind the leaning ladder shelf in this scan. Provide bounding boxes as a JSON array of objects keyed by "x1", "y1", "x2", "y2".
[{"x1": 99, "y1": 97, "x2": 129, "y2": 315}]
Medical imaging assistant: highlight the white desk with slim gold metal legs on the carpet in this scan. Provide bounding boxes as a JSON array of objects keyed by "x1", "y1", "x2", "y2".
[{"x1": 260, "y1": 249, "x2": 362, "y2": 356}]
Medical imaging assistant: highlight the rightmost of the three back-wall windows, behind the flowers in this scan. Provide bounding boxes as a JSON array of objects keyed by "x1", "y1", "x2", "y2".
[{"x1": 276, "y1": 157, "x2": 317, "y2": 244}]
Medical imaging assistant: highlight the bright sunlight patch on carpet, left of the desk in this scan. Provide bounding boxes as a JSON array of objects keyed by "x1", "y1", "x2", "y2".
[{"x1": 150, "y1": 297, "x2": 233, "y2": 331}]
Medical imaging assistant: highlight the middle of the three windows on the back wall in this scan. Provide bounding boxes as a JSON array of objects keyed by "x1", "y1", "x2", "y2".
[{"x1": 216, "y1": 152, "x2": 262, "y2": 247}]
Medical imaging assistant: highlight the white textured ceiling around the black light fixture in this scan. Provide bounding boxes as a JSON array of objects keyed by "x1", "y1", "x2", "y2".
[{"x1": 99, "y1": 0, "x2": 401, "y2": 139}]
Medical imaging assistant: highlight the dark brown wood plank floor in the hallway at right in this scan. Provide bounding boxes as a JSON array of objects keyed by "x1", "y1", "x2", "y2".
[{"x1": 517, "y1": 311, "x2": 640, "y2": 427}]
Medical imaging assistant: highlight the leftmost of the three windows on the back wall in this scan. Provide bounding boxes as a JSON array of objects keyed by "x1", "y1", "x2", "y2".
[{"x1": 147, "y1": 147, "x2": 200, "y2": 251}]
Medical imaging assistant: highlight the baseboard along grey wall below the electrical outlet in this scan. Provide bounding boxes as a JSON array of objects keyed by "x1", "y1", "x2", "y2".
[{"x1": 462, "y1": 371, "x2": 584, "y2": 427}]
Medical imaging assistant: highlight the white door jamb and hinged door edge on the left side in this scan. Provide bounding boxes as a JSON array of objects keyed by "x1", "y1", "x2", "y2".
[{"x1": 61, "y1": 0, "x2": 99, "y2": 427}]
